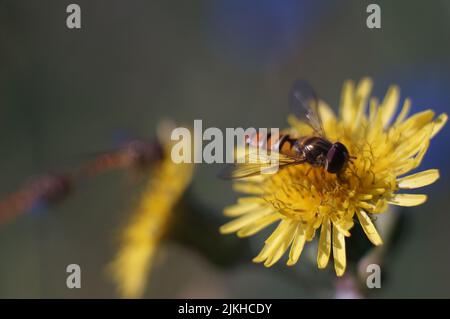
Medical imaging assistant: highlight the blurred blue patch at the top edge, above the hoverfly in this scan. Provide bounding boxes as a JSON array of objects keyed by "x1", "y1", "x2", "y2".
[{"x1": 207, "y1": 0, "x2": 331, "y2": 69}]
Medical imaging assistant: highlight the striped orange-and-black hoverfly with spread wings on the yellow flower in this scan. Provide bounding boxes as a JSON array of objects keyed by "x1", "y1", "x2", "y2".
[{"x1": 221, "y1": 80, "x2": 352, "y2": 179}]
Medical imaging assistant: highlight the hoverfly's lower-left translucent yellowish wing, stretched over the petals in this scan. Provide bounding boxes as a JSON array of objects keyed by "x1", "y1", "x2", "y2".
[{"x1": 219, "y1": 151, "x2": 305, "y2": 179}]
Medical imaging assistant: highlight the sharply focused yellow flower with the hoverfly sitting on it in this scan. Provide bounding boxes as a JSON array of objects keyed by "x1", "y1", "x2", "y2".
[{"x1": 220, "y1": 78, "x2": 447, "y2": 276}]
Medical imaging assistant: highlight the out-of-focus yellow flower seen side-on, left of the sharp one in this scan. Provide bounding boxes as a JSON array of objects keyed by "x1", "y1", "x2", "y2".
[{"x1": 108, "y1": 124, "x2": 193, "y2": 298}]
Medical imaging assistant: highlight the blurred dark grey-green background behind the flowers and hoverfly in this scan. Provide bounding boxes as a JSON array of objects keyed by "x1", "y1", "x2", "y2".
[{"x1": 0, "y1": 0, "x2": 450, "y2": 298}]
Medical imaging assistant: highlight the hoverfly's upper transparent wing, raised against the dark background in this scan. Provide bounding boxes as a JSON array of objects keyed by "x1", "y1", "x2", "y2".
[{"x1": 289, "y1": 80, "x2": 325, "y2": 136}]
